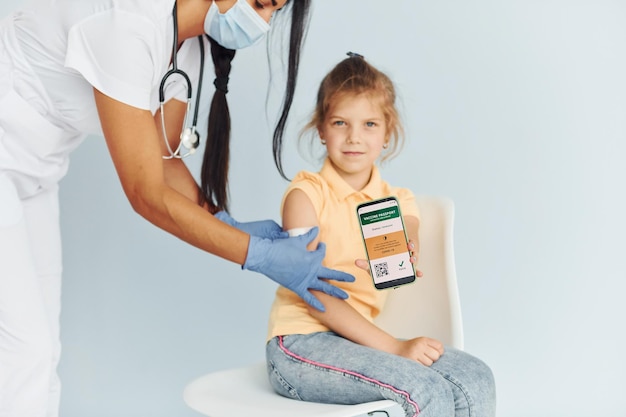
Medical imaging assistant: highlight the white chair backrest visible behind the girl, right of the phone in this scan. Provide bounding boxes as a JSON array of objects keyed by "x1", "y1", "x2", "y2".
[{"x1": 376, "y1": 196, "x2": 463, "y2": 349}]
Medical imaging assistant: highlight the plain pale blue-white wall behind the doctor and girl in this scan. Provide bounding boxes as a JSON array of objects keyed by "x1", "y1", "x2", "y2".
[{"x1": 0, "y1": 0, "x2": 626, "y2": 417}]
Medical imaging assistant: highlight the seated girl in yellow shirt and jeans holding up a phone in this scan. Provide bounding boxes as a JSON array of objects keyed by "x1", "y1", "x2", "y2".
[{"x1": 266, "y1": 54, "x2": 495, "y2": 417}]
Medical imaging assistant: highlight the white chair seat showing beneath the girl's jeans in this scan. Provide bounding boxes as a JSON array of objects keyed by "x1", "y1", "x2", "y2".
[{"x1": 184, "y1": 362, "x2": 397, "y2": 417}]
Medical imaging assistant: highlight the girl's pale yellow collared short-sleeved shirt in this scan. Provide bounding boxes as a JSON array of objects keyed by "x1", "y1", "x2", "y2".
[{"x1": 268, "y1": 159, "x2": 419, "y2": 340}]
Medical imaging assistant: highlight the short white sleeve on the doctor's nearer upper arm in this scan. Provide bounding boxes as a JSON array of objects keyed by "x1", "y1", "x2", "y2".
[{"x1": 65, "y1": 10, "x2": 167, "y2": 110}]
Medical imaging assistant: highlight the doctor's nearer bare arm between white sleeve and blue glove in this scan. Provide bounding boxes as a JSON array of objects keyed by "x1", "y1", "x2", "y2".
[{"x1": 94, "y1": 90, "x2": 250, "y2": 265}]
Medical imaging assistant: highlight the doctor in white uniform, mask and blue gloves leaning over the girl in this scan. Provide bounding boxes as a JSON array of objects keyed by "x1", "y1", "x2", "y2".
[{"x1": 0, "y1": 0, "x2": 353, "y2": 417}]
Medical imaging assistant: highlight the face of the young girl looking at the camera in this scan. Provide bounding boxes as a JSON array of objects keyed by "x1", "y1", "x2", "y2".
[{"x1": 318, "y1": 94, "x2": 388, "y2": 190}]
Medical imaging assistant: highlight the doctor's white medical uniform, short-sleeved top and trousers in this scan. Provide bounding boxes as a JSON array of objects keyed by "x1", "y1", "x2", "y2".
[{"x1": 0, "y1": 0, "x2": 208, "y2": 417}]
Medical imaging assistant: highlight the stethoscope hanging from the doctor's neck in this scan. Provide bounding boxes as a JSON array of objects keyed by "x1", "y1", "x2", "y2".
[{"x1": 159, "y1": 2, "x2": 204, "y2": 159}]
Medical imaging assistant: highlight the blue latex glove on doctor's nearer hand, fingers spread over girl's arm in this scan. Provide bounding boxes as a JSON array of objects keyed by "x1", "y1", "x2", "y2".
[{"x1": 243, "y1": 227, "x2": 354, "y2": 311}]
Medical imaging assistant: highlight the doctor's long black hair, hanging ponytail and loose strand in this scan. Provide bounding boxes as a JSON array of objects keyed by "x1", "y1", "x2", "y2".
[{"x1": 199, "y1": 0, "x2": 311, "y2": 213}]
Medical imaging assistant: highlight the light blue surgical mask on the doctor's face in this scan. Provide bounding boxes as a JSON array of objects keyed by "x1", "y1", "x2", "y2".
[{"x1": 204, "y1": 0, "x2": 270, "y2": 49}]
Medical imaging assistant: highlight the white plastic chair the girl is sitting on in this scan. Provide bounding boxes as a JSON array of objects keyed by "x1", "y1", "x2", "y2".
[{"x1": 184, "y1": 196, "x2": 463, "y2": 417}]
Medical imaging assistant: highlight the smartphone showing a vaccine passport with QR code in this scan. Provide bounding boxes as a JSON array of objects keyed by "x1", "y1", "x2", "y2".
[{"x1": 356, "y1": 197, "x2": 415, "y2": 290}]
